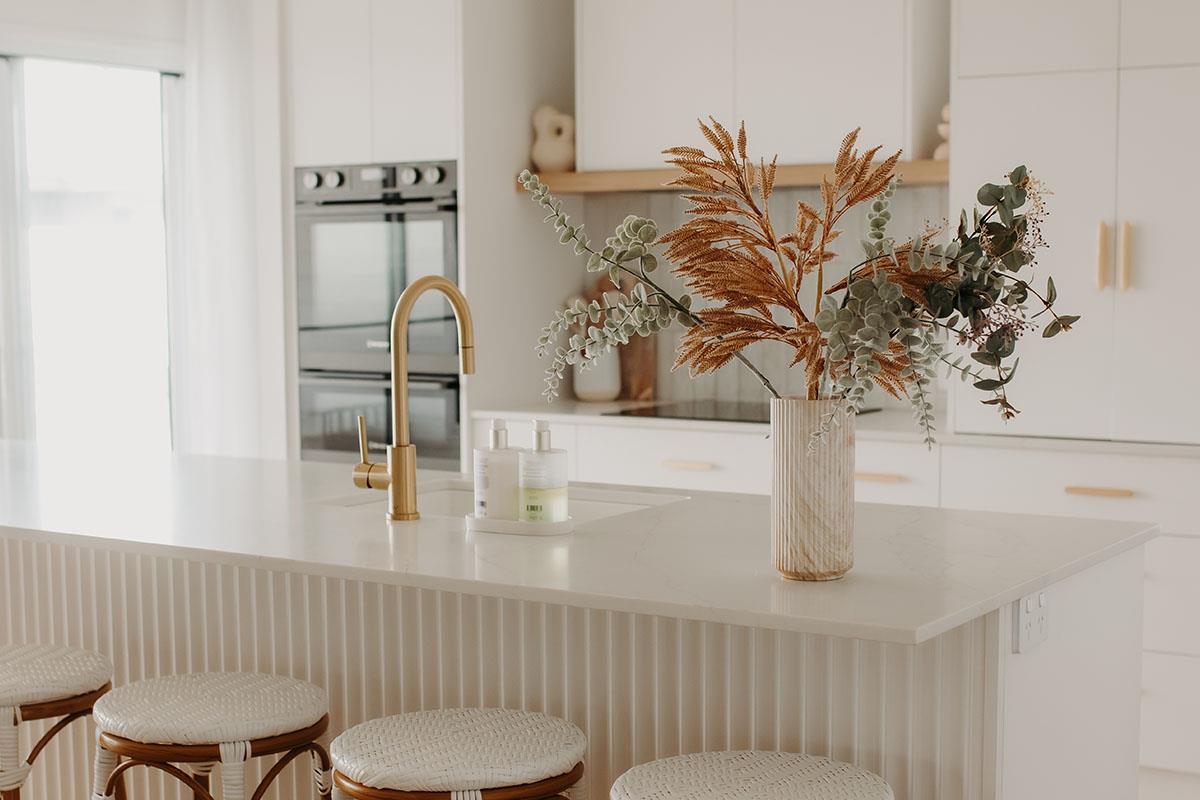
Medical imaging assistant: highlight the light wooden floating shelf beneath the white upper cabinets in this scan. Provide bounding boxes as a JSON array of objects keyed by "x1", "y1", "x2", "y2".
[{"x1": 516, "y1": 160, "x2": 950, "y2": 194}]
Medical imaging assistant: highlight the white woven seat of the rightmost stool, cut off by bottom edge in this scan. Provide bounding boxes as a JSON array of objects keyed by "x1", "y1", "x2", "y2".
[{"x1": 611, "y1": 751, "x2": 893, "y2": 800}]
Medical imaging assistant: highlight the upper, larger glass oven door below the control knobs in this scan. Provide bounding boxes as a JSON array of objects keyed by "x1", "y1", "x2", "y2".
[{"x1": 296, "y1": 204, "x2": 458, "y2": 373}]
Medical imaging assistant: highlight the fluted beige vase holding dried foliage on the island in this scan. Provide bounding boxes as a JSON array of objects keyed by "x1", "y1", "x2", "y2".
[{"x1": 770, "y1": 397, "x2": 854, "y2": 581}]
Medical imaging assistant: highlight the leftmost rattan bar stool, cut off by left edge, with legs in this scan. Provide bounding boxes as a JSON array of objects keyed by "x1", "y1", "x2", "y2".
[{"x1": 0, "y1": 644, "x2": 113, "y2": 800}]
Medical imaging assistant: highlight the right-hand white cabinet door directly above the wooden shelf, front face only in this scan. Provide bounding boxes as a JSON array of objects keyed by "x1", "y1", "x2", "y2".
[{"x1": 733, "y1": 0, "x2": 902, "y2": 163}]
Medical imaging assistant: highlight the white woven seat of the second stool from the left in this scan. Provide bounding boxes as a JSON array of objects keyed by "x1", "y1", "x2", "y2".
[{"x1": 94, "y1": 672, "x2": 328, "y2": 745}]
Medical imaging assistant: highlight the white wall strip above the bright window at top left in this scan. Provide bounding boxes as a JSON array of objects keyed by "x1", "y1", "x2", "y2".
[{"x1": 0, "y1": 0, "x2": 186, "y2": 71}]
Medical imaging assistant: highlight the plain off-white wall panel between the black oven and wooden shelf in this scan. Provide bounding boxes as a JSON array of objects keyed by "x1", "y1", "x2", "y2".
[{"x1": 460, "y1": 0, "x2": 580, "y2": 438}]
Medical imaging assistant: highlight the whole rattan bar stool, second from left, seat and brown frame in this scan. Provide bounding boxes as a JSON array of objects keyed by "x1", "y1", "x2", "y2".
[{"x1": 92, "y1": 672, "x2": 330, "y2": 800}]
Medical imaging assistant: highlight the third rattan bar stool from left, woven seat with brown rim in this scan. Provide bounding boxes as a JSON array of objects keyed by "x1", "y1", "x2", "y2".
[{"x1": 329, "y1": 709, "x2": 588, "y2": 800}]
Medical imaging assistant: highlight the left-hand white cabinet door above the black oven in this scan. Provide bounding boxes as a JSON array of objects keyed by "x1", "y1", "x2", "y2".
[{"x1": 292, "y1": 0, "x2": 371, "y2": 166}]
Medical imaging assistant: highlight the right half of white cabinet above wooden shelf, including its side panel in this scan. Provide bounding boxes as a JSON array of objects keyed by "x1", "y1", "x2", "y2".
[{"x1": 733, "y1": 0, "x2": 949, "y2": 163}]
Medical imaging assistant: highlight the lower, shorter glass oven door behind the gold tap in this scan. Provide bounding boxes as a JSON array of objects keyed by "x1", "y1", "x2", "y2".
[{"x1": 300, "y1": 373, "x2": 461, "y2": 473}]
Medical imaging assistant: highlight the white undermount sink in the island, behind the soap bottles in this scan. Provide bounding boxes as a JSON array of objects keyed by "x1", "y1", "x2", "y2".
[{"x1": 318, "y1": 479, "x2": 688, "y2": 524}]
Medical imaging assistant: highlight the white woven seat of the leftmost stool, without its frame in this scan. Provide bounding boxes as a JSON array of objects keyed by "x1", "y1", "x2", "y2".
[{"x1": 0, "y1": 644, "x2": 113, "y2": 708}]
